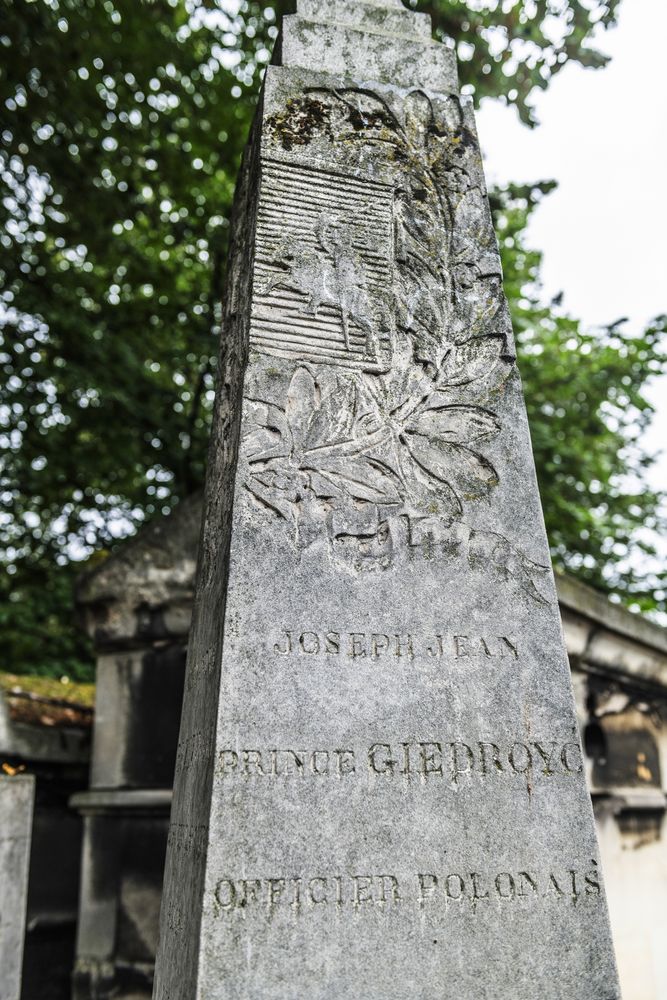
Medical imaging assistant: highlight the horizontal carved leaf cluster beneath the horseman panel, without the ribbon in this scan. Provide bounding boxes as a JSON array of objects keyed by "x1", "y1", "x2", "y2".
[{"x1": 244, "y1": 366, "x2": 500, "y2": 523}]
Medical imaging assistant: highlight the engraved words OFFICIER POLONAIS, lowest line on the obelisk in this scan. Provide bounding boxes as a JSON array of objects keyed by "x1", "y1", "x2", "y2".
[{"x1": 214, "y1": 861, "x2": 601, "y2": 915}]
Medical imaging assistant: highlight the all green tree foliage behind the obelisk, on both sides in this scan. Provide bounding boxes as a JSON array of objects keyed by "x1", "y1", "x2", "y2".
[{"x1": 0, "y1": 0, "x2": 658, "y2": 676}]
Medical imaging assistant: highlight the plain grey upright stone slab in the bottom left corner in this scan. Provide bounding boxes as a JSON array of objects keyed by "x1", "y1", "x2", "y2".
[{"x1": 0, "y1": 775, "x2": 35, "y2": 1000}]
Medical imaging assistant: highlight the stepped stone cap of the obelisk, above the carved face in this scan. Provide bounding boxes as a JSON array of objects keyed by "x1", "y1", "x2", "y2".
[{"x1": 277, "y1": 0, "x2": 458, "y2": 92}]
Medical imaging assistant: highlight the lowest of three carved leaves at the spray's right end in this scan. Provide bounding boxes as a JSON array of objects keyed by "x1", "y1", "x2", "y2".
[{"x1": 404, "y1": 433, "x2": 498, "y2": 500}]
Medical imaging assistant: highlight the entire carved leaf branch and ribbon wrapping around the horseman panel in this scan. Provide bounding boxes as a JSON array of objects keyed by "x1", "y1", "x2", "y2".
[{"x1": 253, "y1": 89, "x2": 547, "y2": 603}]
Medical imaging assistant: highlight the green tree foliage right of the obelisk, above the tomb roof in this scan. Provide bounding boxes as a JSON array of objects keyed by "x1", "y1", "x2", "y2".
[{"x1": 492, "y1": 183, "x2": 667, "y2": 611}]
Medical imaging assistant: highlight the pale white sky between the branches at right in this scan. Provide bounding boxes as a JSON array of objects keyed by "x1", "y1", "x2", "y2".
[{"x1": 477, "y1": 0, "x2": 667, "y2": 489}]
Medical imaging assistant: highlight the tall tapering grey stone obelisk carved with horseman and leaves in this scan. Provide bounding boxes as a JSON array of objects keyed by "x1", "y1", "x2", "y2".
[{"x1": 154, "y1": 0, "x2": 619, "y2": 1000}]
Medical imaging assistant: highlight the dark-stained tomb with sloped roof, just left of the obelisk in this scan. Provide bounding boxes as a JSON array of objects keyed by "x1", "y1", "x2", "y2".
[{"x1": 72, "y1": 496, "x2": 201, "y2": 1000}]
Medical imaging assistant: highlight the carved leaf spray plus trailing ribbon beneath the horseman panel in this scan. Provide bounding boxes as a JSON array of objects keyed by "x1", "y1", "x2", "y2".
[{"x1": 244, "y1": 366, "x2": 548, "y2": 604}]
